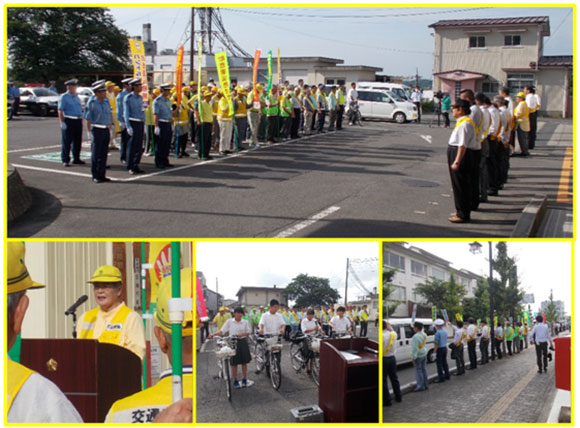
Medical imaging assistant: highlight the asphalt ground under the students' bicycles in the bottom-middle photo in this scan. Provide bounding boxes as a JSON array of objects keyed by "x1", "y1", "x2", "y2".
[{"x1": 196, "y1": 323, "x2": 378, "y2": 423}]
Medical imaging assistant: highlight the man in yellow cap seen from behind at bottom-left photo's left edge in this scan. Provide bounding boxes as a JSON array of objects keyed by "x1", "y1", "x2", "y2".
[{"x1": 5, "y1": 242, "x2": 83, "y2": 424}]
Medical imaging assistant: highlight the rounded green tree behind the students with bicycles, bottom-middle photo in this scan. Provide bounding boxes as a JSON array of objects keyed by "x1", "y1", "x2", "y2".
[{"x1": 284, "y1": 273, "x2": 340, "y2": 307}]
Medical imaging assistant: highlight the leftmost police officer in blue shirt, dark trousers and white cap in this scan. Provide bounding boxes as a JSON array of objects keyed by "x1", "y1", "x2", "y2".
[{"x1": 58, "y1": 79, "x2": 85, "y2": 167}]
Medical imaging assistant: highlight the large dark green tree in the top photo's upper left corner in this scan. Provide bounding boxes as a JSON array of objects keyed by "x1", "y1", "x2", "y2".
[{"x1": 7, "y1": 7, "x2": 130, "y2": 82}]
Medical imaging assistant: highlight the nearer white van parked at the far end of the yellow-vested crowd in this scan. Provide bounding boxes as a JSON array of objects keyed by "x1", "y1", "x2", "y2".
[{"x1": 357, "y1": 89, "x2": 417, "y2": 123}]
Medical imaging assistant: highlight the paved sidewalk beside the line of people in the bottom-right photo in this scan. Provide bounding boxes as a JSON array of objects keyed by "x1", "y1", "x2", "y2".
[{"x1": 383, "y1": 346, "x2": 556, "y2": 423}]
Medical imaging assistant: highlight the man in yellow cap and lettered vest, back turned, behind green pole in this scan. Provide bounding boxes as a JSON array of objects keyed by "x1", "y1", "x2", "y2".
[{"x1": 105, "y1": 268, "x2": 193, "y2": 423}]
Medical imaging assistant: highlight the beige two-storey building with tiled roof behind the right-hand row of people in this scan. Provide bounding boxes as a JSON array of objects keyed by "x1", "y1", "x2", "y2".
[{"x1": 429, "y1": 16, "x2": 573, "y2": 117}]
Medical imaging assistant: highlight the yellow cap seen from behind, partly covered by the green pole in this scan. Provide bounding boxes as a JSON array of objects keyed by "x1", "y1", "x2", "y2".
[{"x1": 153, "y1": 268, "x2": 193, "y2": 336}]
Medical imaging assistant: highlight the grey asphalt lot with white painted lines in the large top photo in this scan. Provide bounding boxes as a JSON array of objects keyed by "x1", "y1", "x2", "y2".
[{"x1": 8, "y1": 116, "x2": 572, "y2": 238}]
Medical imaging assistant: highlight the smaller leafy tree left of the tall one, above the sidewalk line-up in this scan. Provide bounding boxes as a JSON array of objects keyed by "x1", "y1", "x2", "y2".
[{"x1": 415, "y1": 274, "x2": 467, "y2": 318}]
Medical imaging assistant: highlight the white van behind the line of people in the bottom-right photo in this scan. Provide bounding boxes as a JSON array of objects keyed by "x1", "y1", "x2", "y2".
[{"x1": 389, "y1": 318, "x2": 453, "y2": 365}]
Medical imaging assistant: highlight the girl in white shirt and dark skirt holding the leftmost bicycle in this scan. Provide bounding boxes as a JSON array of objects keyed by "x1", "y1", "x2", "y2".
[{"x1": 209, "y1": 307, "x2": 252, "y2": 388}]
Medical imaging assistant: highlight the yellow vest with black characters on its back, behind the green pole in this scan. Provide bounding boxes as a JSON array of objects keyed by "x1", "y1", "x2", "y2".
[{"x1": 105, "y1": 367, "x2": 193, "y2": 424}]
